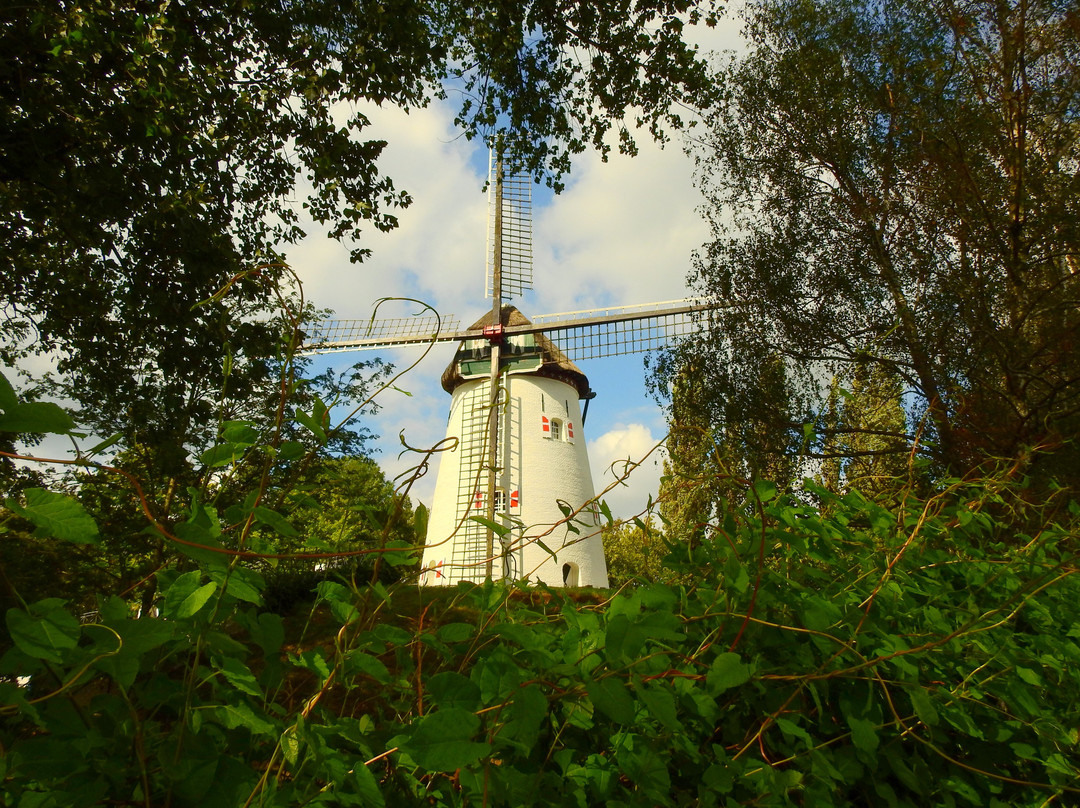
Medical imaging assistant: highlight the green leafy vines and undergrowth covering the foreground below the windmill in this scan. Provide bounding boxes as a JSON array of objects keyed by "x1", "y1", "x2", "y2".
[{"x1": 0, "y1": 375, "x2": 1080, "y2": 808}]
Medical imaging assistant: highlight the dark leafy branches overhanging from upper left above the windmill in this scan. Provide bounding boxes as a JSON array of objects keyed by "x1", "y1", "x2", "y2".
[{"x1": 0, "y1": 0, "x2": 712, "y2": 477}]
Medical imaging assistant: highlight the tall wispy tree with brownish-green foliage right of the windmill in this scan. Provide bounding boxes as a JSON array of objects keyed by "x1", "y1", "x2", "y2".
[{"x1": 678, "y1": 0, "x2": 1080, "y2": 492}]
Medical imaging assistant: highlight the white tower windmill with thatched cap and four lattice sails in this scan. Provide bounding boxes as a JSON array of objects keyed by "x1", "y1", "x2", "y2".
[{"x1": 305, "y1": 158, "x2": 712, "y2": 587}]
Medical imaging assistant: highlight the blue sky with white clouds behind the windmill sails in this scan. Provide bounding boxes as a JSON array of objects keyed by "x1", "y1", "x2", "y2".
[{"x1": 288, "y1": 14, "x2": 738, "y2": 517}]
